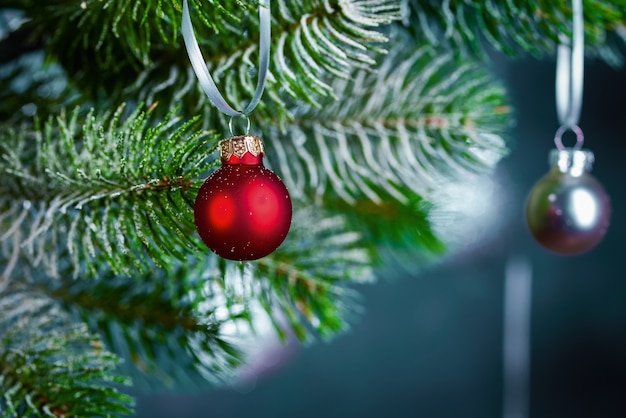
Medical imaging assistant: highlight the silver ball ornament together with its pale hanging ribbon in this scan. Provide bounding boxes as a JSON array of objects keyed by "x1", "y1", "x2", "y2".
[{"x1": 526, "y1": 0, "x2": 611, "y2": 255}]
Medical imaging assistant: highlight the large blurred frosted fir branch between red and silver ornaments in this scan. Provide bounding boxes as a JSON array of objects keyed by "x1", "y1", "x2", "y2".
[{"x1": 268, "y1": 30, "x2": 509, "y2": 210}]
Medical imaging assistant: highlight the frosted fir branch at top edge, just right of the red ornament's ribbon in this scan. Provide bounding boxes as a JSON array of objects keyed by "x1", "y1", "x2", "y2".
[{"x1": 270, "y1": 0, "x2": 401, "y2": 105}]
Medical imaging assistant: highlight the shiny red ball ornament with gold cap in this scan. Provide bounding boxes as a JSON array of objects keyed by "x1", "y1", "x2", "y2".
[{"x1": 194, "y1": 135, "x2": 291, "y2": 261}]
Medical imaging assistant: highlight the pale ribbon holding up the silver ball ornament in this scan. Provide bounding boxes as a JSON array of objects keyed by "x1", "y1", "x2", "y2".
[{"x1": 556, "y1": 0, "x2": 585, "y2": 129}]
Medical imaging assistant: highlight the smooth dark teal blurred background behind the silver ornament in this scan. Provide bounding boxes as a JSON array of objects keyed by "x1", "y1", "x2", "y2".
[{"x1": 138, "y1": 52, "x2": 626, "y2": 418}]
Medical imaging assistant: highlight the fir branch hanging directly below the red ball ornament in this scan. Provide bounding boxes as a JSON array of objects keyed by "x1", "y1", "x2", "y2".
[{"x1": 13, "y1": 202, "x2": 374, "y2": 390}]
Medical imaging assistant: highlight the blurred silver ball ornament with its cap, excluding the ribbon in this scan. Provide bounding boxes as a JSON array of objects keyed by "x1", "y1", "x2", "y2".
[{"x1": 526, "y1": 148, "x2": 611, "y2": 255}]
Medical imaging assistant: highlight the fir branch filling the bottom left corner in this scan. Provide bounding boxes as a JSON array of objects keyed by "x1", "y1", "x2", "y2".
[{"x1": 0, "y1": 289, "x2": 133, "y2": 418}]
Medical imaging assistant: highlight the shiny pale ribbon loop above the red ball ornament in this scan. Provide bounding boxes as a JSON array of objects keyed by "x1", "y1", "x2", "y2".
[{"x1": 182, "y1": 0, "x2": 271, "y2": 117}]
